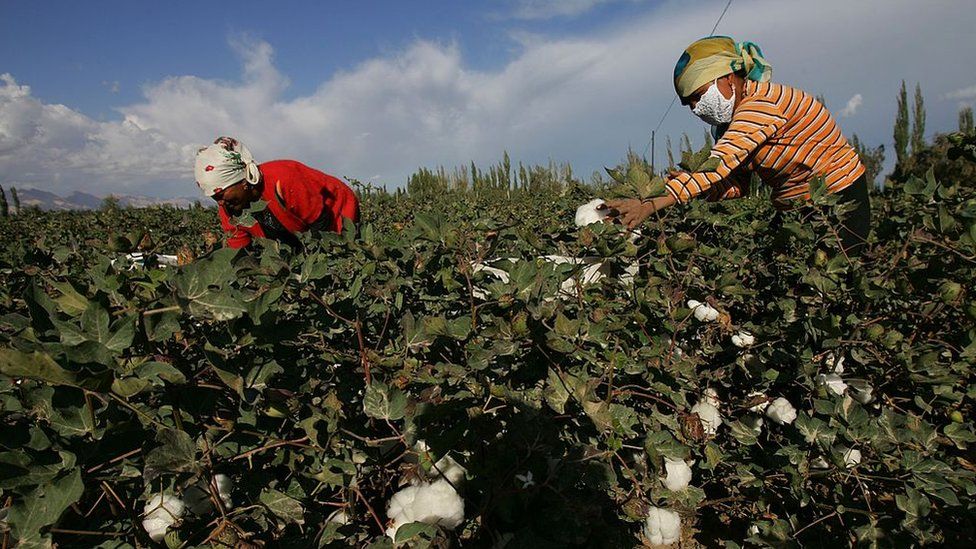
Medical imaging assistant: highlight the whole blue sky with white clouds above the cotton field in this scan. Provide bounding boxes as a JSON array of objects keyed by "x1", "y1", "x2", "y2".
[{"x1": 0, "y1": 0, "x2": 976, "y2": 196}]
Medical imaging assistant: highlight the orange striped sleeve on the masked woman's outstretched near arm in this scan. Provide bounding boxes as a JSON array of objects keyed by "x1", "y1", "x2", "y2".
[{"x1": 667, "y1": 98, "x2": 786, "y2": 202}]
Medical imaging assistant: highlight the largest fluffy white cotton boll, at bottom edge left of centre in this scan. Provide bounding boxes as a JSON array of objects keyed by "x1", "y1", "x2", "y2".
[{"x1": 386, "y1": 479, "x2": 464, "y2": 540}]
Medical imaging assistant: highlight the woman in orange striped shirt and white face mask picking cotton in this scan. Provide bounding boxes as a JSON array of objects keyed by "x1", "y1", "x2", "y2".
[{"x1": 608, "y1": 36, "x2": 871, "y2": 253}]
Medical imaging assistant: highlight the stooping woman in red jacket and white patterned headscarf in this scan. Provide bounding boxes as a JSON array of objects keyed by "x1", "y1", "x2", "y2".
[{"x1": 194, "y1": 137, "x2": 359, "y2": 248}]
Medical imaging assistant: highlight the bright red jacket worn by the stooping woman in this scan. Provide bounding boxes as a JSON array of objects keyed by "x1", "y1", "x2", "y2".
[{"x1": 218, "y1": 160, "x2": 359, "y2": 248}]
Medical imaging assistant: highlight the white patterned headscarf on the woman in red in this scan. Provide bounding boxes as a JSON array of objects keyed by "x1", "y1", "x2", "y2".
[{"x1": 193, "y1": 137, "x2": 261, "y2": 196}]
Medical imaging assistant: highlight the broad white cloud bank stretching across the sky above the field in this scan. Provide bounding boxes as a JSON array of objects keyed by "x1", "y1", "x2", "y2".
[{"x1": 0, "y1": 0, "x2": 976, "y2": 195}]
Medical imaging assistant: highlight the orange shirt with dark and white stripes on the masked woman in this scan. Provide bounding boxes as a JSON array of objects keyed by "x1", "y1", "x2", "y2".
[{"x1": 667, "y1": 80, "x2": 864, "y2": 208}]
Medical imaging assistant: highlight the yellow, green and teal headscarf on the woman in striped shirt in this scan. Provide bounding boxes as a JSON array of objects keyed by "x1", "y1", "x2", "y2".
[{"x1": 674, "y1": 36, "x2": 773, "y2": 98}]
